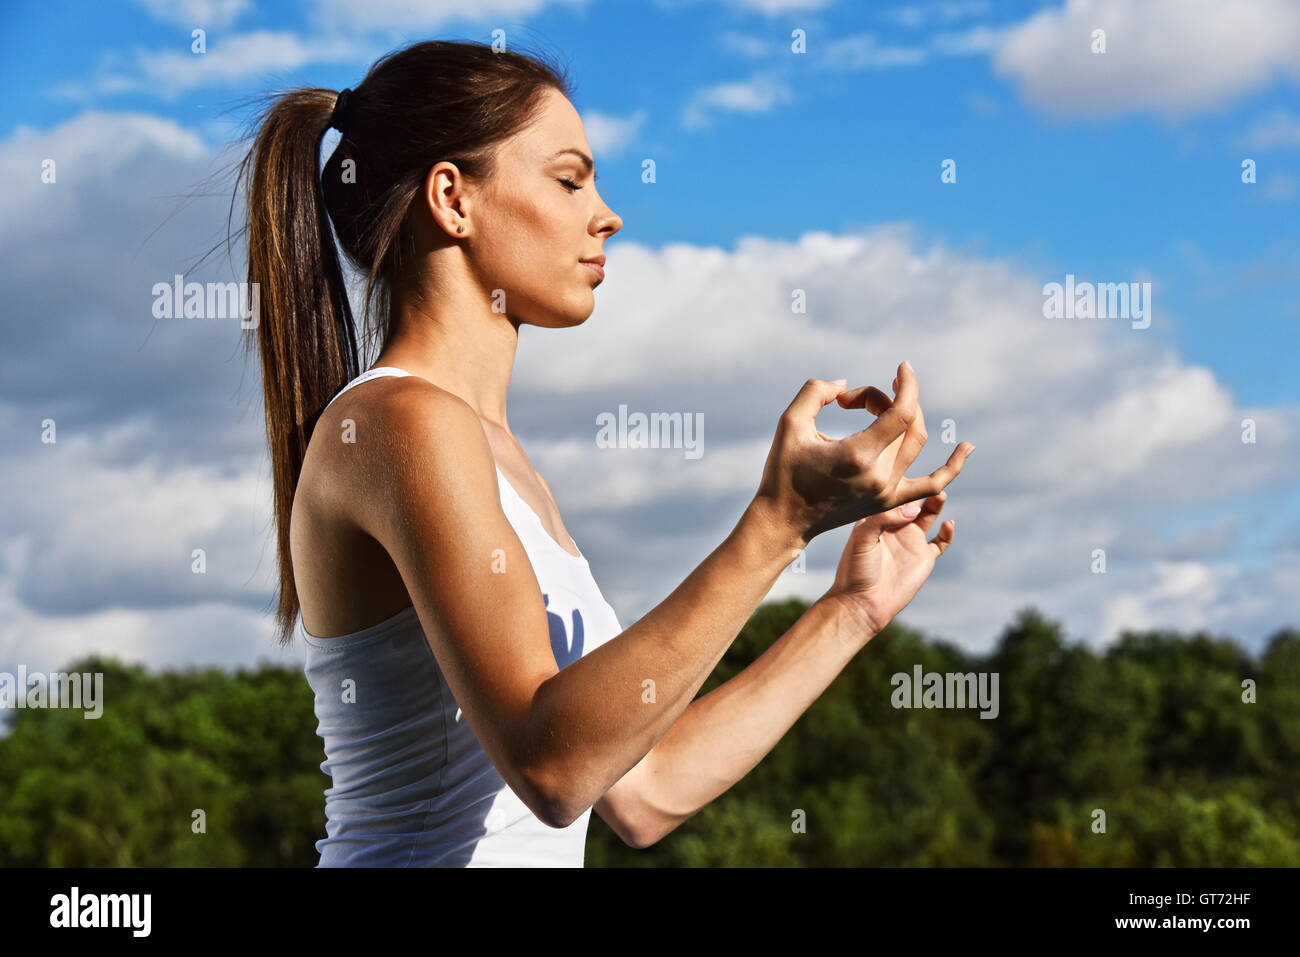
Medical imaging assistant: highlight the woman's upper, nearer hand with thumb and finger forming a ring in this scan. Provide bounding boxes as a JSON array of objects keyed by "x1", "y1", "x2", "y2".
[{"x1": 755, "y1": 363, "x2": 975, "y2": 544}]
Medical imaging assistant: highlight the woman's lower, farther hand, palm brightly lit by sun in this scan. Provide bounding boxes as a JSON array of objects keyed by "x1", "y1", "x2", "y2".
[{"x1": 819, "y1": 490, "x2": 956, "y2": 640}]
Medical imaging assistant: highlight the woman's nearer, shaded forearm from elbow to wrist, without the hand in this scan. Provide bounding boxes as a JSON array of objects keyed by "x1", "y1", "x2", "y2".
[{"x1": 529, "y1": 499, "x2": 801, "y2": 824}]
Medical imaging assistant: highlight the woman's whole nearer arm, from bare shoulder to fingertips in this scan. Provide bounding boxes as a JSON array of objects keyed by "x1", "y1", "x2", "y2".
[{"x1": 351, "y1": 361, "x2": 965, "y2": 827}]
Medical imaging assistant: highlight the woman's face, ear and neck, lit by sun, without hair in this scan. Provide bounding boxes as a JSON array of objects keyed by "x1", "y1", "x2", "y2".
[{"x1": 376, "y1": 83, "x2": 623, "y2": 433}]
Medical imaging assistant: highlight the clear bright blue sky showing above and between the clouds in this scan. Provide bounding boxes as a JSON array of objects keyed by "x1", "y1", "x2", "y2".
[{"x1": 0, "y1": 0, "x2": 1300, "y2": 402}]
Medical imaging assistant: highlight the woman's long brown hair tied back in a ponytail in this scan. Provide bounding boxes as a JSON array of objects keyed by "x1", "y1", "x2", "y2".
[{"x1": 235, "y1": 40, "x2": 571, "y2": 645}]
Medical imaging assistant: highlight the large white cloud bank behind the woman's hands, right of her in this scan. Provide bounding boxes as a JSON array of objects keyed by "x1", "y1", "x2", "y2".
[{"x1": 516, "y1": 226, "x2": 1300, "y2": 646}]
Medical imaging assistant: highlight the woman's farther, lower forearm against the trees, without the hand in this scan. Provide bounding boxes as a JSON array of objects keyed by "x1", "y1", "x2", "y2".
[{"x1": 626, "y1": 601, "x2": 872, "y2": 844}]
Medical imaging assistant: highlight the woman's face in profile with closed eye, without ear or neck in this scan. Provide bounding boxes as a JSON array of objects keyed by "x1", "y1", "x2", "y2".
[{"x1": 452, "y1": 88, "x2": 623, "y2": 328}]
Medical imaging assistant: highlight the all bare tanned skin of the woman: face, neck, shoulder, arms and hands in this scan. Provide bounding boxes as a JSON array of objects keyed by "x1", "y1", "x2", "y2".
[{"x1": 293, "y1": 82, "x2": 970, "y2": 846}]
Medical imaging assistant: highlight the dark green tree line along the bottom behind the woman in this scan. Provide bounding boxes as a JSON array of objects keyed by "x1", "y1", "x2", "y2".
[{"x1": 0, "y1": 601, "x2": 1300, "y2": 867}]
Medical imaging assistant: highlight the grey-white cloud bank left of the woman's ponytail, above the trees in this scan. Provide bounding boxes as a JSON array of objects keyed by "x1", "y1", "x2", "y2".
[{"x1": 0, "y1": 112, "x2": 277, "y2": 668}]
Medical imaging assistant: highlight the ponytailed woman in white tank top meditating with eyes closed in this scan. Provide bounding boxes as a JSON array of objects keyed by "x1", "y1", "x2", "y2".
[{"x1": 233, "y1": 42, "x2": 969, "y2": 866}]
